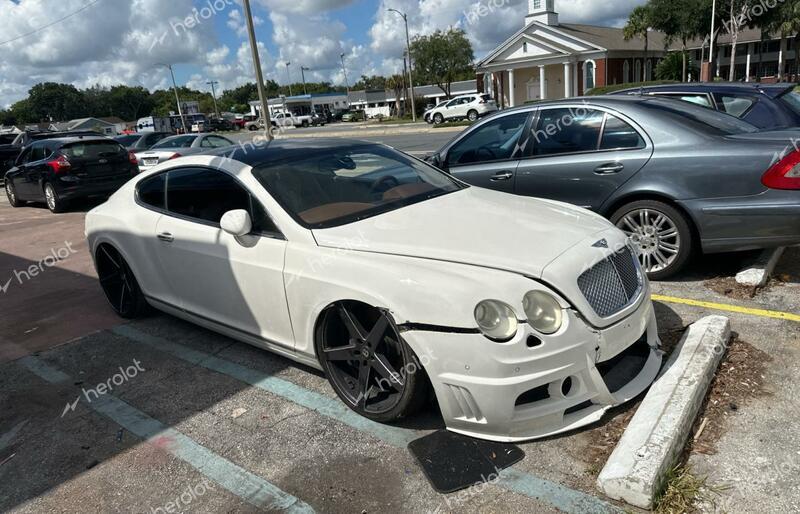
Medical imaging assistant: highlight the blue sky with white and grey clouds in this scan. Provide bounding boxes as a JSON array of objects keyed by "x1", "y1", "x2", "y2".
[{"x1": 0, "y1": 0, "x2": 645, "y2": 108}]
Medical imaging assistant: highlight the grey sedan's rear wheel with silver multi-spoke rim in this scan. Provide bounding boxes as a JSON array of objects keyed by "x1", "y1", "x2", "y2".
[{"x1": 611, "y1": 200, "x2": 695, "y2": 280}]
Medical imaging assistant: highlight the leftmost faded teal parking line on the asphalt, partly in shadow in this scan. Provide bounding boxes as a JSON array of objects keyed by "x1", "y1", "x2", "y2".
[{"x1": 18, "y1": 357, "x2": 314, "y2": 514}]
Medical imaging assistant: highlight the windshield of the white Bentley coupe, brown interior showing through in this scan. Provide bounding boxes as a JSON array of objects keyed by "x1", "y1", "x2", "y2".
[{"x1": 248, "y1": 141, "x2": 466, "y2": 228}]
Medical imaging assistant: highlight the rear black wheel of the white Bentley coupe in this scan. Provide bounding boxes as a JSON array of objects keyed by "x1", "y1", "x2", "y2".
[{"x1": 95, "y1": 244, "x2": 150, "y2": 319}]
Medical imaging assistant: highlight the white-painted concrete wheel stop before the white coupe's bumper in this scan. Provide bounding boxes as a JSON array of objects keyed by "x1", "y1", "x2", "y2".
[{"x1": 597, "y1": 316, "x2": 731, "y2": 509}]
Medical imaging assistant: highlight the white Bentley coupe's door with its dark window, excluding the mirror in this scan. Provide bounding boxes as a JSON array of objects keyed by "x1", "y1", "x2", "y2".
[{"x1": 155, "y1": 167, "x2": 294, "y2": 347}]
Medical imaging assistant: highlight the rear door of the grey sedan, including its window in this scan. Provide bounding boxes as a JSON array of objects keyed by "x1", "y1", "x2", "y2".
[{"x1": 515, "y1": 105, "x2": 653, "y2": 210}]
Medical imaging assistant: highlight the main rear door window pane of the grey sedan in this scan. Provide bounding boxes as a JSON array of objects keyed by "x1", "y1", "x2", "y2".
[{"x1": 533, "y1": 108, "x2": 604, "y2": 155}]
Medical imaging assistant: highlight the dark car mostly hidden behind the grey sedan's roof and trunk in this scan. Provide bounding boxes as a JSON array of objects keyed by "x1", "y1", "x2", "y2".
[{"x1": 612, "y1": 82, "x2": 800, "y2": 129}]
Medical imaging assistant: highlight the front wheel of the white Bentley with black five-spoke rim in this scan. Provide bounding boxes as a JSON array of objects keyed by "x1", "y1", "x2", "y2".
[{"x1": 314, "y1": 301, "x2": 428, "y2": 423}]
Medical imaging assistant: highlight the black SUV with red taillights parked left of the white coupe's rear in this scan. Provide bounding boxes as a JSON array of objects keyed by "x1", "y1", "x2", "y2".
[{"x1": 5, "y1": 136, "x2": 139, "y2": 213}]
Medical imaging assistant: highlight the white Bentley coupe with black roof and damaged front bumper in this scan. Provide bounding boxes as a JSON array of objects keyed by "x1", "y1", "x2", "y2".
[{"x1": 86, "y1": 139, "x2": 662, "y2": 441}]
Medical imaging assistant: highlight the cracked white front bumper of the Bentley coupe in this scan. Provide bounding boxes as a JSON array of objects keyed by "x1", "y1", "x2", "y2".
[{"x1": 403, "y1": 290, "x2": 662, "y2": 442}]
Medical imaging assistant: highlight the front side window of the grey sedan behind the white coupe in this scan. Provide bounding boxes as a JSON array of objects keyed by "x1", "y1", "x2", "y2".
[{"x1": 447, "y1": 112, "x2": 529, "y2": 166}]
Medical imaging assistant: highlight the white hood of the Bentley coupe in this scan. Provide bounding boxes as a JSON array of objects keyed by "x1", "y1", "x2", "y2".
[{"x1": 313, "y1": 187, "x2": 612, "y2": 278}]
